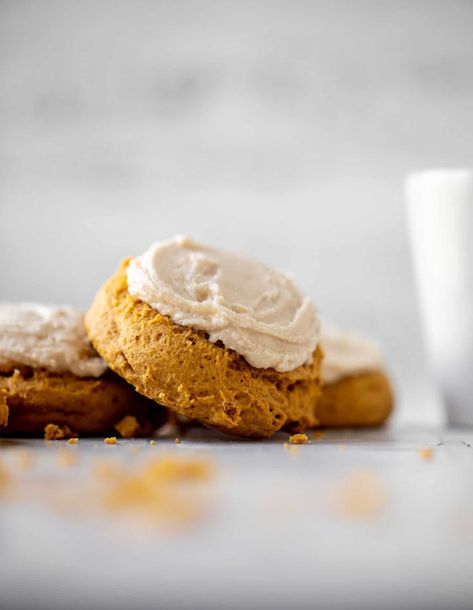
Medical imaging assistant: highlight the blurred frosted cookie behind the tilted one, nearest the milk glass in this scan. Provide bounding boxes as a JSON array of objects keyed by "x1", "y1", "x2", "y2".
[{"x1": 315, "y1": 323, "x2": 394, "y2": 426}]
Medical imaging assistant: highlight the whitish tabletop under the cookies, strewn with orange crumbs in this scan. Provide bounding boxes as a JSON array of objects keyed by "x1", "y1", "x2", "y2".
[{"x1": 0, "y1": 425, "x2": 473, "y2": 609}]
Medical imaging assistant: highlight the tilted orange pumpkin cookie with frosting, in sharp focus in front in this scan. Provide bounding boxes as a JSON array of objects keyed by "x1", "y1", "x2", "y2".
[{"x1": 86, "y1": 237, "x2": 321, "y2": 437}]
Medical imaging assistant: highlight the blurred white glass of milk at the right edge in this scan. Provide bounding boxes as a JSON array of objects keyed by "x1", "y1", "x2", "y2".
[{"x1": 406, "y1": 169, "x2": 473, "y2": 425}]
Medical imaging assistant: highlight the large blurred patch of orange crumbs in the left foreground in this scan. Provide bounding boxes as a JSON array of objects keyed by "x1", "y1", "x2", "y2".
[{"x1": 21, "y1": 454, "x2": 213, "y2": 534}]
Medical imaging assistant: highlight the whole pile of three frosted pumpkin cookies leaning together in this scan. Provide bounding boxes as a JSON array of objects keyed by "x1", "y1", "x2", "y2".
[{"x1": 0, "y1": 237, "x2": 393, "y2": 438}]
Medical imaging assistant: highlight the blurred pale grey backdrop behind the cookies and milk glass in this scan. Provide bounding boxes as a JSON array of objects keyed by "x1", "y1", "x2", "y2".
[{"x1": 0, "y1": 0, "x2": 473, "y2": 415}]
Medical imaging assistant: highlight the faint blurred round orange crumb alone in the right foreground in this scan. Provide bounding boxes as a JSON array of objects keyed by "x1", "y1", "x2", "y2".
[{"x1": 334, "y1": 470, "x2": 386, "y2": 520}]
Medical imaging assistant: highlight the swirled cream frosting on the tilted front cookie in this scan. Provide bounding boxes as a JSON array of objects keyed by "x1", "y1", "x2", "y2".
[{"x1": 127, "y1": 236, "x2": 320, "y2": 372}]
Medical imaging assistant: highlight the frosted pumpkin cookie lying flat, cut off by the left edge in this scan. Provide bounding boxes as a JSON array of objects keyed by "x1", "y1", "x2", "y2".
[{"x1": 0, "y1": 303, "x2": 164, "y2": 436}]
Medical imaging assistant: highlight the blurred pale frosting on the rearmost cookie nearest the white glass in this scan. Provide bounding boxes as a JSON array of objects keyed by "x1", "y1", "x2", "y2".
[{"x1": 320, "y1": 321, "x2": 384, "y2": 384}]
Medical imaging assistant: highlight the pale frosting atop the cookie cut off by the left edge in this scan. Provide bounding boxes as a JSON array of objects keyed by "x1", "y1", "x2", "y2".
[{"x1": 0, "y1": 303, "x2": 107, "y2": 377}]
